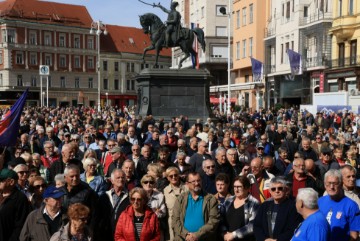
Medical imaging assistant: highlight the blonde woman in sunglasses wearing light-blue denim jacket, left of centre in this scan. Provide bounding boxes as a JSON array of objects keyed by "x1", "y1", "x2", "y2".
[{"x1": 80, "y1": 157, "x2": 108, "y2": 196}]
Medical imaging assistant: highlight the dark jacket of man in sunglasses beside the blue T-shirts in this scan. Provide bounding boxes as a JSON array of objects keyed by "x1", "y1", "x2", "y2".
[{"x1": 254, "y1": 199, "x2": 303, "y2": 241}]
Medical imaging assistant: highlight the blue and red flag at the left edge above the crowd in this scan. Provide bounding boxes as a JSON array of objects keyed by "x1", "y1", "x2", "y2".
[{"x1": 0, "y1": 89, "x2": 29, "y2": 146}]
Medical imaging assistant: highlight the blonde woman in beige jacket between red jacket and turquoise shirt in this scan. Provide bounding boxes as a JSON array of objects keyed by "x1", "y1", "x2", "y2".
[{"x1": 164, "y1": 167, "x2": 187, "y2": 240}]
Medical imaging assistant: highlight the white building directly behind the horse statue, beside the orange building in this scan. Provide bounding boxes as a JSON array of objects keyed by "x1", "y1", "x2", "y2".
[{"x1": 172, "y1": 0, "x2": 231, "y2": 86}]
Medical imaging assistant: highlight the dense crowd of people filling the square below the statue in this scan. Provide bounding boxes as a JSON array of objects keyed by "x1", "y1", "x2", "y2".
[{"x1": 0, "y1": 107, "x2": 360, "y2": 241}]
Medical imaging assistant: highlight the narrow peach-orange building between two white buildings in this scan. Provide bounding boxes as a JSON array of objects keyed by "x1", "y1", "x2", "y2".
[{"x1": 231, "y1": 0, "x2": 268, "y2": 111}]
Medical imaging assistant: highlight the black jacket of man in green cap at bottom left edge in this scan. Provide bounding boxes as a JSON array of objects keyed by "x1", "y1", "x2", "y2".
[{"x1": 0, "y1": 187, "x2": 30, "y2": 241}]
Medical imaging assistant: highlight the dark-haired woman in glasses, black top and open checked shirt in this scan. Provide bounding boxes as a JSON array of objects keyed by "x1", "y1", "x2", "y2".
[{"x1": 220, "y1": 176, "x2": 260, "y2": 241}]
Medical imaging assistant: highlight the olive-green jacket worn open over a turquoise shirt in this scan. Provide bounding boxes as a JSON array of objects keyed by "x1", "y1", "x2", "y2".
[{"x1": 172, "y1": 191, "x2": 220, "y2": 241}]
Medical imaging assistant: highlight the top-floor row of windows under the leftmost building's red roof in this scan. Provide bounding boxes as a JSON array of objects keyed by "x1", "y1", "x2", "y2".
[{"x1": 1, "y1": 28, "x2": 95, "y2": 49}]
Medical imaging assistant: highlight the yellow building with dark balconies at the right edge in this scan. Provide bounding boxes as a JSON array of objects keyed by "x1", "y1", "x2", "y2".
[{"x1": 323, "y1": 0, "x2": 360, "y2": 93}]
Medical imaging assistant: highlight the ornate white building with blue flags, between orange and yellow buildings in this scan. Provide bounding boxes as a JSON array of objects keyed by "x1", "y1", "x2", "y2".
[{"x1": 264, "y1": 0, "x2": 332, "y2": 107}]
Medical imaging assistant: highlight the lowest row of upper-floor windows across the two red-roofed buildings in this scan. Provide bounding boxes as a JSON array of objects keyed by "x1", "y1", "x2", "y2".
[{"x1": 13, "y1": 75, "x2": 135, "y2": 90}]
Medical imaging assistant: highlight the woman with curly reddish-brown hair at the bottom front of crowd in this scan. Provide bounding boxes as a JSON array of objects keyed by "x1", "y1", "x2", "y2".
[{"x1": 50, "y1": 203, "x2": 92, "y2": 241}]
